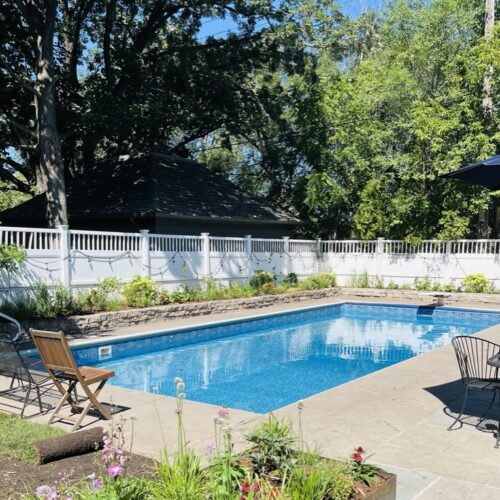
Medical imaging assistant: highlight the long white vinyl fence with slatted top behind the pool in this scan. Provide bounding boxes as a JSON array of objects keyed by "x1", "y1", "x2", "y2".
[{"x1": 0, "y1": 226, "x2": 500, "y2": 290}]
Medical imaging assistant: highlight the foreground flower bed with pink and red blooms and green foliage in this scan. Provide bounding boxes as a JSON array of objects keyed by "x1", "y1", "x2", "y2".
[{"x1": 28, "y1": 377, "x2": 395, "y2": 500}]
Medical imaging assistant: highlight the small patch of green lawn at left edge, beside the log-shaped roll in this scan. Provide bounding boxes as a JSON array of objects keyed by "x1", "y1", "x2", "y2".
[{"x1": 0, "y1": 412, "x2": 65, "y2": 464}]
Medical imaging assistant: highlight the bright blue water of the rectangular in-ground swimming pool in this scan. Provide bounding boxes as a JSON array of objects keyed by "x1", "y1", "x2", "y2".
[{"x1": 74, "y1": 303, "x2": 500, "y2": 413}]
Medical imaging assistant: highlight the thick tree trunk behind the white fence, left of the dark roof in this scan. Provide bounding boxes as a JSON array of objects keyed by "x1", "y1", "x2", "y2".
[{"x1": 36, "y1": 0, "x2": 68, "y2": 227}]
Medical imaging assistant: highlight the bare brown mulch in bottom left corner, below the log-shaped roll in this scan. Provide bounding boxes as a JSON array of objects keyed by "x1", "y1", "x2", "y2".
[{"x1": 0, "y1": 453, "x2": 154, "y2": 500}]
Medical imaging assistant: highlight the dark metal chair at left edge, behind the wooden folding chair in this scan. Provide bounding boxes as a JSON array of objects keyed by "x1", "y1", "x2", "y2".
[{"x1": 0, "y1": 313, "x2": 53, "y2": 417}]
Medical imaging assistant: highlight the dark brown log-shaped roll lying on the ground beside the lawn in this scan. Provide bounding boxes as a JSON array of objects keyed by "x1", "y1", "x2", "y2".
[{"x1": 33, "y1": 427, "x2": 104, "y2": 464}]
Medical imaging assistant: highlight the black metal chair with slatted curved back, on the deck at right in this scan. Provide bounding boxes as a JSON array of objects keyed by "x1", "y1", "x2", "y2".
[{"x1": 448, "y1": 335, "x2": 500, "y2": 448}]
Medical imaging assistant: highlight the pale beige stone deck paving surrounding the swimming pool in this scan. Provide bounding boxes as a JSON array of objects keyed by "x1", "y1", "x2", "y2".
[{"x1": 0, "y1": 297, "x2": 500, "y2": 500}]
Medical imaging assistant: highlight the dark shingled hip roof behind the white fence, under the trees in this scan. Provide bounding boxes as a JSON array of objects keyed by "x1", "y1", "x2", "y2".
[{"x1": 0, "y1": 153, "x2": 300, "y2": 225}]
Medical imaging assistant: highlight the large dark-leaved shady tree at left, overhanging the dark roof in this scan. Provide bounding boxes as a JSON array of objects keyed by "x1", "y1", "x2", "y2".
[{"x1": 0, "y1": 0, "x2": 324, "y2": 225}]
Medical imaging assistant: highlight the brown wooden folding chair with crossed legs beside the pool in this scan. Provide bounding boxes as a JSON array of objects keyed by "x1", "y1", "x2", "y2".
[{"x1": 30, "y1": 329, "x2": 115, "y2": 431}]
